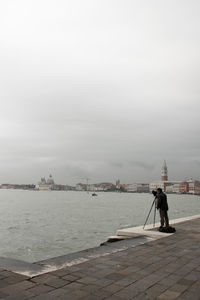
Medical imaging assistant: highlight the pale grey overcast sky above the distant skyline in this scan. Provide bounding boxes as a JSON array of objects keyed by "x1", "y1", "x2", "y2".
[{"x1": 0, "y1": 0, "x2": 200, "y2": 184}]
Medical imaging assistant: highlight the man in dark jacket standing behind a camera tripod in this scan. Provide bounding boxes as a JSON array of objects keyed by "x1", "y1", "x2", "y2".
[{"x1": 156, "y1": 188, "x2": 169, "y2": 228}]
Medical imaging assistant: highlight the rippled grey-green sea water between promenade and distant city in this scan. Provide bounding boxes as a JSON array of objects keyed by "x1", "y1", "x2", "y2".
[{"x1": 0, "y1": 189, "x2": 200, "y2": 262}]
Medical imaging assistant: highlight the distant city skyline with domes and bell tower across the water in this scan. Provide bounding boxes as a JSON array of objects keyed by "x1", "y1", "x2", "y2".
[{"x1": 0, "y1": 160, "x2": 200, "y2": 196}]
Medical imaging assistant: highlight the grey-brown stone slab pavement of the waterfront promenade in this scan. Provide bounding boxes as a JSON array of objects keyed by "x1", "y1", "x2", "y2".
[{"x1": 0, "y1": 218, "x2": 200, "y2": 300}]
